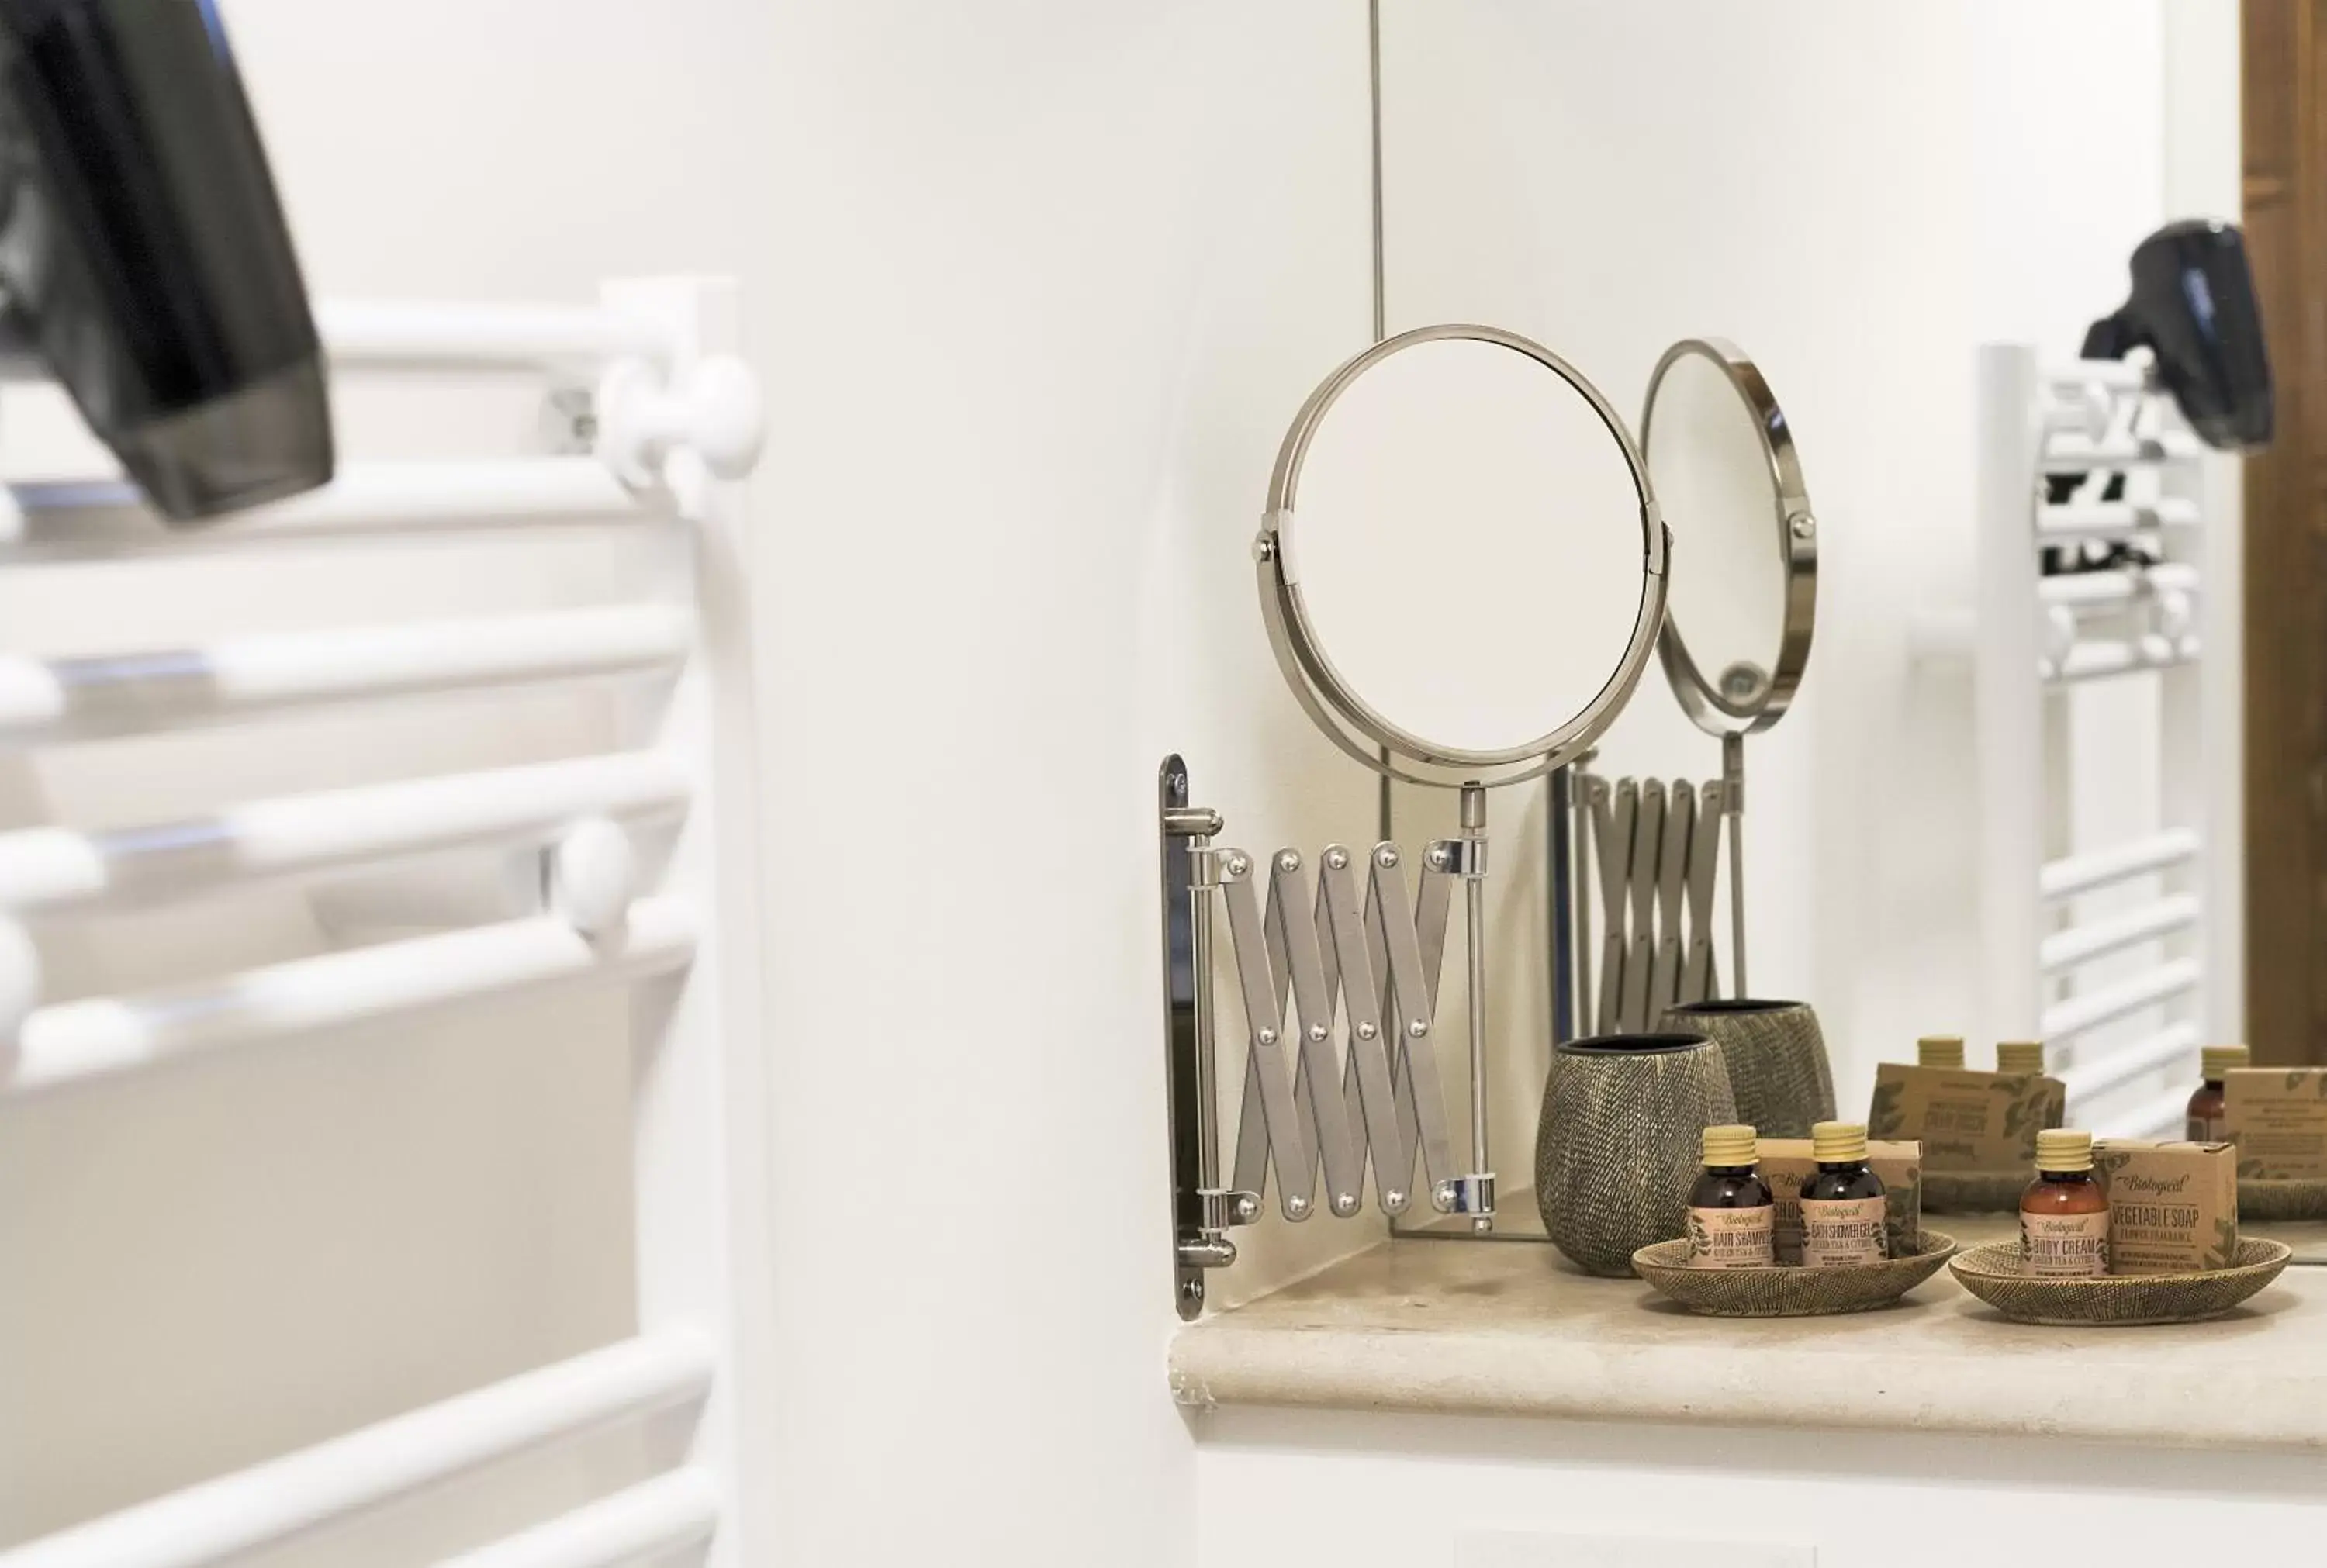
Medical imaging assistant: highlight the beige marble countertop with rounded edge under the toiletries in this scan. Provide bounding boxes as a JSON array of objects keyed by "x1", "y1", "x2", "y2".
[{"x1": 1170, "y1": 1217, "x2": 2327, "y2": 1449}]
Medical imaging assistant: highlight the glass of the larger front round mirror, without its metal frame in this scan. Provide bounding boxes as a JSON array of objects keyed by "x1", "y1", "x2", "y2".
[{"x1": 1291, "y1": 340, "x2": 1643, "y2": 751}]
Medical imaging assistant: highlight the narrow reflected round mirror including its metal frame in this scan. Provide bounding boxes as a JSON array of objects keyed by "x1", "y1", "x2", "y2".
[{"x1": 1641, "y1": 337, "x2": 1817, "y2": 735}]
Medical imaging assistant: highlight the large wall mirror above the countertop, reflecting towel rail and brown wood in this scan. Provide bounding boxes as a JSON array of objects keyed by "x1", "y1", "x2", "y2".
[{"x1": 1359, "y1": 0, "x2": 2327, "y2": 1256}]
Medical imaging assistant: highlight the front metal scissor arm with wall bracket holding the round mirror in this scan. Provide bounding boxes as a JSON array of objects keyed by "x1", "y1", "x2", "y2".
[{"x1": 1159, "y1": 758, "x2": 1494, "y2": 1317}]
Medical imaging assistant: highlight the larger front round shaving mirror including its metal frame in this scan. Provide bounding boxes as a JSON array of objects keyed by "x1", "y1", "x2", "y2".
[{"x1": 1259, "y1": 326, "x2": 1666, "y2": 784}]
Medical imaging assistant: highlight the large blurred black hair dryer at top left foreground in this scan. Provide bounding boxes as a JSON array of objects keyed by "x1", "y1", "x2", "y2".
[{"x1": 0, "y1": 0, "x2": 333, "y2": 521}]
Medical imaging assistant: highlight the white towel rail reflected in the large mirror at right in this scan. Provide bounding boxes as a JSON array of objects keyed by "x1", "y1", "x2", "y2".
[{"x1": 1917, "y1": 344, "x2": 2239, "y2": 1135}]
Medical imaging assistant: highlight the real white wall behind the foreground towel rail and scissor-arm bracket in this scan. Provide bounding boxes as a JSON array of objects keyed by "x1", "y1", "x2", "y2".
[{"x1": 0, "y1": 0, "x2": 1371, "y2": 1563}]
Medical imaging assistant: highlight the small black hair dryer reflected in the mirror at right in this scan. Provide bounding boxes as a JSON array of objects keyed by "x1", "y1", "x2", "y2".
[{"x1": 2085, "y1": 219, "x2": 2271, "y2": 449}]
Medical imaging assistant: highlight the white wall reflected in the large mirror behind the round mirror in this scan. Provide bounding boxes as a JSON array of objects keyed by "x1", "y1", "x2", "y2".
[{"x1": 1385, "y1": 0, "x2": 2236, "y2": 1126}]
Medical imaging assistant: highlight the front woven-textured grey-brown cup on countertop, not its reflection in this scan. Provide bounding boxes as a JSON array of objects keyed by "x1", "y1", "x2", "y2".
[{"x1": 1536, "y1": 1035, "x2": 1738, "y2": 1277}]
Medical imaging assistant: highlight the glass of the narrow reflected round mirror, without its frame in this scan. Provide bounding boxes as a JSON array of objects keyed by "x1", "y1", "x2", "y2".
[{"x1": 1643, "y1": 354, "x2": 1785, "y2": 712}]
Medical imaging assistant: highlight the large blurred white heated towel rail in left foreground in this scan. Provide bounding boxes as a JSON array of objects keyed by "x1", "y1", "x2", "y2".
[{"x1": 0, "y1": 279, "x2": 766, "y2": 1568}]
